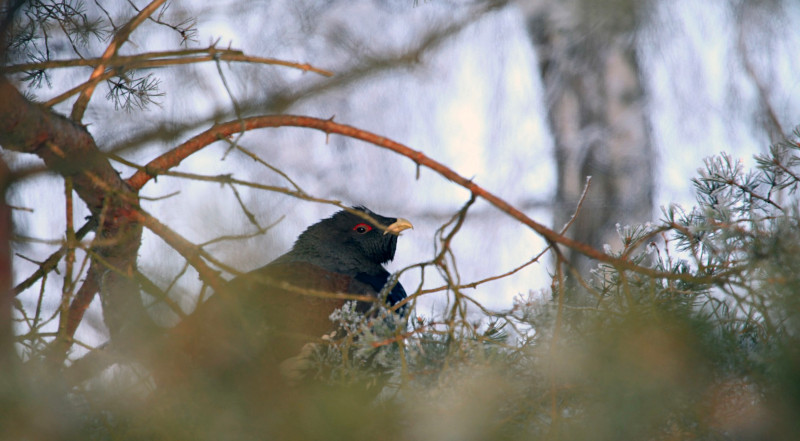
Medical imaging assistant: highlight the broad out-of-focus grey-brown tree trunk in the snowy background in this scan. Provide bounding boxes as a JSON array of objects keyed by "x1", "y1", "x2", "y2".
[{"x1": 528, "y1": 0, "x2": 655, "y2": 292}]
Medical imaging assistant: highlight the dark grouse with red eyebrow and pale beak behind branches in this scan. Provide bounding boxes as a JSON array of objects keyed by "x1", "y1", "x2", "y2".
[{"x1": 156, "y1": 207, "x2": 413, "y2": 386}]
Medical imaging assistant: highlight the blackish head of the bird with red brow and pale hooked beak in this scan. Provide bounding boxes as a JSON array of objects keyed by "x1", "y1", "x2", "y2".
[{"x1": 290, "y1": 207, "x2": 413, "y2": 276}]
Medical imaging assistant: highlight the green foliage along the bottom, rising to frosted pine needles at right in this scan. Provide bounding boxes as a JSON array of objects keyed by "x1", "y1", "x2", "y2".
[{"x1": 0, "y1": 129, "x2": 800, "y2": 440}]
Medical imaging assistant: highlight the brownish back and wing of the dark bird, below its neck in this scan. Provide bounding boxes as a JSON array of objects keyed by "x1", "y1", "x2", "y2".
[{"x1": 159, "y1": 262, "x2": 384, "y2": 383}]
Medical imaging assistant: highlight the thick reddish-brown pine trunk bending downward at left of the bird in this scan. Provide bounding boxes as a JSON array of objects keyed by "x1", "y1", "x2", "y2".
[{"x1": 0, "y1": 77, "x2": 146, "y2": 358}]
